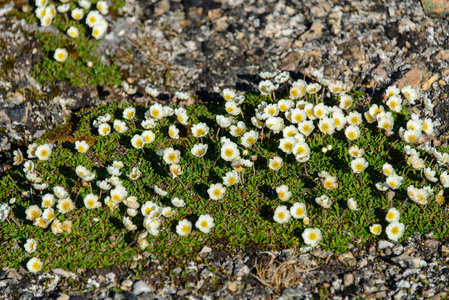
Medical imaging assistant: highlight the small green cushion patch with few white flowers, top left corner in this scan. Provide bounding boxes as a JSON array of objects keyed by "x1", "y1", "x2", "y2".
[{"x1": 26, "y1": 0, "x2": 125, "y2": 86}]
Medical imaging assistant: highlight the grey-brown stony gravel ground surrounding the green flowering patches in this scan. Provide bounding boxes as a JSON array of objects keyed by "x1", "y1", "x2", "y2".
[{"x1": 0, "y1": 0, "x2": 449, "y2": 299}]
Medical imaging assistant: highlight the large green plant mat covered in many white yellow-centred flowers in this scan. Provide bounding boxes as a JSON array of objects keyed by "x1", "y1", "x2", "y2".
[{"x1": 0, "y1": 70, "x2": 449, "y2": 271}]
